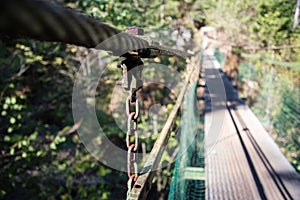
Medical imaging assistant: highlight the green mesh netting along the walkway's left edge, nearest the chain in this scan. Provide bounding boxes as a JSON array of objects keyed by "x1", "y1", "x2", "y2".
[{"x1": 168, "y1": 82, "x2": 205, "y2": 200}]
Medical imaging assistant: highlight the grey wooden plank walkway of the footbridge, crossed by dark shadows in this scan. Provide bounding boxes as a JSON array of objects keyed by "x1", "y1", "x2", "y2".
[{"x1": 203, "y1": 55, "x2": 300, "y2": 200}]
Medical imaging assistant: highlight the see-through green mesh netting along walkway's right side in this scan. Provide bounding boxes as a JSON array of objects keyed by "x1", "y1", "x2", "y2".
[{"x1": 216, "y1": 48, "x2": 300, "y2": 172}]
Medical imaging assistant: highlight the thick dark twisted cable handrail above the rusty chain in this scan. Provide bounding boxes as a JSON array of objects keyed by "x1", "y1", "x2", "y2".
[{"x1": 0, "y1": 0, "x2": 189, "y2": 58}]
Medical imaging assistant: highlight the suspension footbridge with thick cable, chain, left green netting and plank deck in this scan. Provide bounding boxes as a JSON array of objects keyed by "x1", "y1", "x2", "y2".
[{"x1": 0, "y1": 0, "x2": 300, "y2": 200}]
